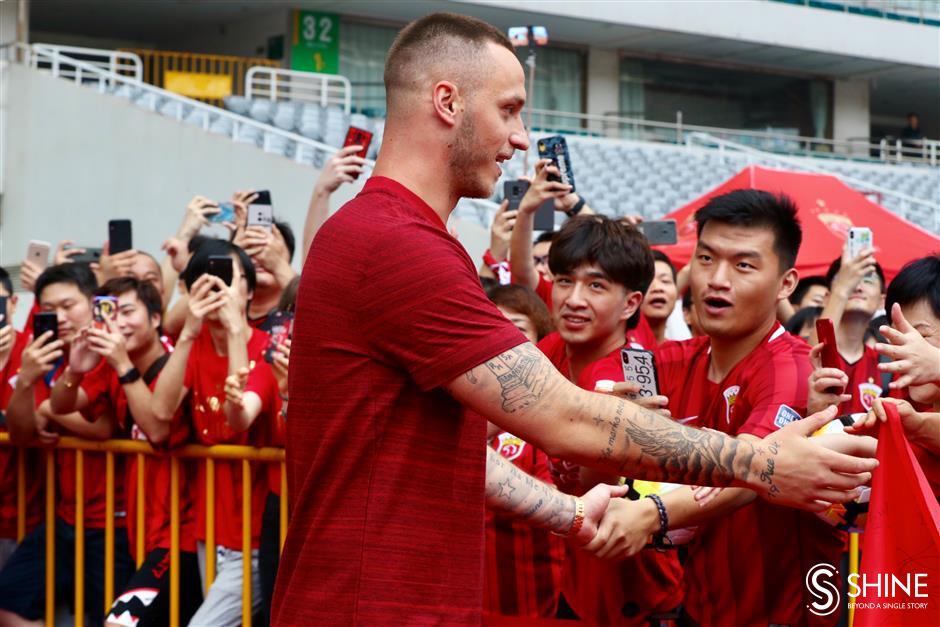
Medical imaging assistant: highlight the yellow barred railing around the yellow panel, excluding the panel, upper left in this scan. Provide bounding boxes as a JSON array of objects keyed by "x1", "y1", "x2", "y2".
[{"x1": 123, "y1": 48, "x2": 281, "y2": 105}]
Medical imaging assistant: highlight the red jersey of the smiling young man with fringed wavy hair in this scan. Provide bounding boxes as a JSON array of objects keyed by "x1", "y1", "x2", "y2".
[{"x1": 538, "y1": 331, "x2": 682, "y2": 625}]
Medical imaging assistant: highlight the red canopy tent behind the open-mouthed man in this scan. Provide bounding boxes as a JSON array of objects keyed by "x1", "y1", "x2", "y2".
[{"x1": 656, "y1": 166, "x2": 940, "y2": 281}]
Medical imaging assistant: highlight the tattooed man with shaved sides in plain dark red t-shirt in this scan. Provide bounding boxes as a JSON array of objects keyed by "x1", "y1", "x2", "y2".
[{"x1": 276, "y1": 14, "x2": 874, "y2": 625}]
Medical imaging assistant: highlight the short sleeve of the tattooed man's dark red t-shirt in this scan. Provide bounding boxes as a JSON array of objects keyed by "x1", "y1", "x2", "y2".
[{"x1": 359, "y1": 225, "x2": 526, "y2": 390}]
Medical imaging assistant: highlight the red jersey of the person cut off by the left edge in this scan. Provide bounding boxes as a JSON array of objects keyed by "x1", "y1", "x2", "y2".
[{"x1": 0, "y1": 331, "x2": 45, "y2": 540}]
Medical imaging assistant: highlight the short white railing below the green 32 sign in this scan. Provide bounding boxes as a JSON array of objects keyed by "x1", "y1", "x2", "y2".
[{"x1": 245, "y1": 65, "x2": 352, "y2": 113}]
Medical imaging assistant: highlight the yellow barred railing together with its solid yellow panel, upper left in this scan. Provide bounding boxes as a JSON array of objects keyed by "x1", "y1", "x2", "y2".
[{"x1": 121, "y1": 48, "x2": 281, "y2": 106}]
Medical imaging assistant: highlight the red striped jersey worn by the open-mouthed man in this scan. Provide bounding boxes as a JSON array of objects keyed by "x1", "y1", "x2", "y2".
[{"x1": 656, "y1": 322, "x2": 843, "y2": 625}]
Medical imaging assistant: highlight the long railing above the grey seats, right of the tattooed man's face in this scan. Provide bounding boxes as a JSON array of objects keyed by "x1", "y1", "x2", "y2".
[{"x1": 532, "y1": 109, "x2": 940, "y2": 166}]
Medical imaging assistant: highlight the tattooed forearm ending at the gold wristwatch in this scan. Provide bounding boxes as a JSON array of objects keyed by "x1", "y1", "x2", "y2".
[{"x1": 486, "y1": 447, "x2": 575, "y2": 533}]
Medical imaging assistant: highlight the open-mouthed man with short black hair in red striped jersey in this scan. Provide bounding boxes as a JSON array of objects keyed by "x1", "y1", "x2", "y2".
[{"x1": 589, "y1": 190, "x2": 842, "y2": 625}]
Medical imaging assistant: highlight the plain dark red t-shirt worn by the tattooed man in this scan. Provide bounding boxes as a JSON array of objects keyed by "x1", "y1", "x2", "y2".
[{"x1": 272, "y1": 176, "x2": 526, "y2": 626}]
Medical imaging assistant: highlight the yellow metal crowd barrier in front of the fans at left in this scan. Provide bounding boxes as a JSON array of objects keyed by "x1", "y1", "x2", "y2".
[{"x1": 0, "y1": 433, "x2": 287, "y2": 627}]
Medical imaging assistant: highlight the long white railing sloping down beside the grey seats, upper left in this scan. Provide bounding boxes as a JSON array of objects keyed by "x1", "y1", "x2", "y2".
[{"x1": 20, "y1": 46, "x2": 374, "y2": 168}]
